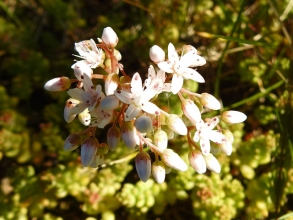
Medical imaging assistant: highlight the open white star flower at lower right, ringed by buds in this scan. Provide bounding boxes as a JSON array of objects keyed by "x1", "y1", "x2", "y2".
[{"x1": 193, "y1": 117, "x2": 227, "y2": 156}]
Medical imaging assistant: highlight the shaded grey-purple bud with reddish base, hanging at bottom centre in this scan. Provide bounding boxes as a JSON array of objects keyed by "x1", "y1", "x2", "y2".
[{"x1": 135, "y1": 151, "x2": 151, "y2": 182}]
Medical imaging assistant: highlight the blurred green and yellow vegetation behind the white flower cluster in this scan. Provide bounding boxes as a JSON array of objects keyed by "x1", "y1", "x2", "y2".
[{"x1": 0, "y1": 0, "x2": 293, "y2": 220}]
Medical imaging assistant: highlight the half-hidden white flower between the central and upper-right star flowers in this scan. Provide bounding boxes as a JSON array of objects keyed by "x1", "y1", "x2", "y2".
[{"x1": 144, "y1": 65, "x2": 171, "y2": 95}]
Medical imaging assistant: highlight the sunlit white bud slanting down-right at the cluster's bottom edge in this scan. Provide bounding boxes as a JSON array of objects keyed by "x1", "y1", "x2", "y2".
[{"x1": 160, "y1": 149, "x2": 187, "y2": 171}]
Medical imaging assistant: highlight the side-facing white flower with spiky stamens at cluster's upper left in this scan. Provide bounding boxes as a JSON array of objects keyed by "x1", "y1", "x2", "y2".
[{"x1": 71, "y1": 39, "x2": 104, "y2": 68}]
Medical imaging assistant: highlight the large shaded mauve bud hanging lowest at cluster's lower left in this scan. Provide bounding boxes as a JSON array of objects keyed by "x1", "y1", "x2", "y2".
[{"x1": 80, "y1": 137, "x2": 99, "y2": 167}]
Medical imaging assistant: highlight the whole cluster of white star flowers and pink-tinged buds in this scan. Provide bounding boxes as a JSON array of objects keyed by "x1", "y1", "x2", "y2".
[{"x1": 45, "y1": 27, "x2": 246, "y2": 183}]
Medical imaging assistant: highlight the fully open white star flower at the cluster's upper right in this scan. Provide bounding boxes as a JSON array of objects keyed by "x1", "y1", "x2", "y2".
[{"x1": 158, "y1": 43, "x2": 205, "y2": 94}]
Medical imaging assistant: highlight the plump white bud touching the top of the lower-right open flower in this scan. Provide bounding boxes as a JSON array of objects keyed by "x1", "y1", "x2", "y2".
[{"x1": 181, "y1": 99, "x2": 201, "y2": 124}]
